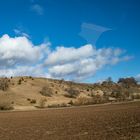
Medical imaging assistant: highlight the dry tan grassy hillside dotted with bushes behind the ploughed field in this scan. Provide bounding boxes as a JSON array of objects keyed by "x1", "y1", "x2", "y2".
[{"x1": 0, "y1": 77, "x2": 140, "y2": 110}]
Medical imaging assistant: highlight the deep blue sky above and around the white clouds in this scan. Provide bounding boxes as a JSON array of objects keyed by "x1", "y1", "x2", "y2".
[{"x1": 0, "y1": 0, "x2": 140, "y2": 82}]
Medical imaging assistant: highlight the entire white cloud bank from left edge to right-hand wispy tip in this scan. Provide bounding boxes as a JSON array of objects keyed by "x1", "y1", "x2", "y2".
[{"x1": 0, "y1": 34, "x2": 132, "y2": 81}]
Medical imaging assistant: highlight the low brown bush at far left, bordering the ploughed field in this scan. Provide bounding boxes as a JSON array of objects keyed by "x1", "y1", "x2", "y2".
[{"x1": 0, "y1": 101, "x2": 14, "y2": 110}]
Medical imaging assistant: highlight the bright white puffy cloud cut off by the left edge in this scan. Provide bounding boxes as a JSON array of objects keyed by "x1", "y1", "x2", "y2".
[{"x1": 0, "y1": 34, "x2": 49, "y2": 72}]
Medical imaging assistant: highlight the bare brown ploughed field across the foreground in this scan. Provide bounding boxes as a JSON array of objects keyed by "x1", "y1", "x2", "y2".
[{"x1": 0, "y1": 102, "x2": 140, "y2": 140}]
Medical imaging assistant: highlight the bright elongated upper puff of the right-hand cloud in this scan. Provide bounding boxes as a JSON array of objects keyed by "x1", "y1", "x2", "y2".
[{"x1": 46, "y1": 45, "x2": 94, "y2": 65}]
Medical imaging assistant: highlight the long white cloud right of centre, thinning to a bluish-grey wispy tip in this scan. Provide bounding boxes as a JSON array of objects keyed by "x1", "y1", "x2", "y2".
[{"x1": 45, "y1": 44, "x2": 131, "y2": 81}]
